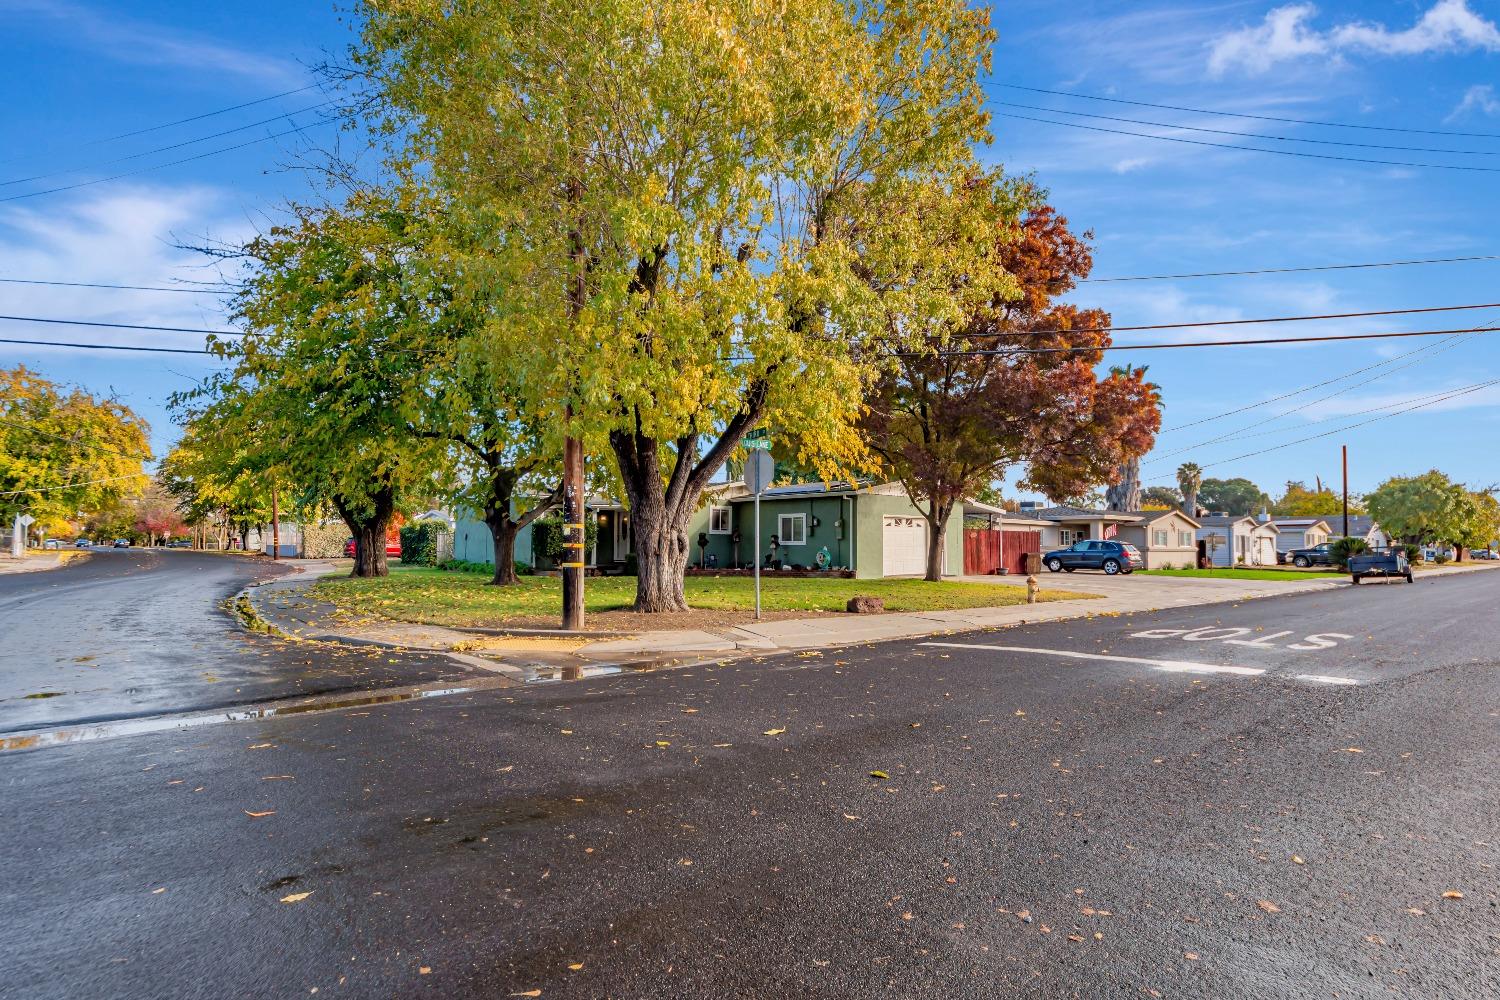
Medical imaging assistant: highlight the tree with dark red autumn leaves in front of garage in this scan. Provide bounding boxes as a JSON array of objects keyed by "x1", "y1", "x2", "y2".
[{"x1": 864, "y1": 187, "x2": 1161, "y2": 580}]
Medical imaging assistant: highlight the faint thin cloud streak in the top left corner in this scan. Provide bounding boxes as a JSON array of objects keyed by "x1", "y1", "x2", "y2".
[{"x1": 0, "y1": 0, "x2": 308, "y2": 87}]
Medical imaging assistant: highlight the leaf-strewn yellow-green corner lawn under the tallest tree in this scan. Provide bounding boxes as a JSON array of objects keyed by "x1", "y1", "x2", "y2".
[{"x1": 314, "y1": 567, "x2": 1088, "y2": 628}]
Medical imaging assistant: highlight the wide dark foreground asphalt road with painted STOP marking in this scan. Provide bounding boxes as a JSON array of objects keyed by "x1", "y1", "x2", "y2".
[{"x1": 0, "y1": 563, "x2": 1500, "y2": 1000}]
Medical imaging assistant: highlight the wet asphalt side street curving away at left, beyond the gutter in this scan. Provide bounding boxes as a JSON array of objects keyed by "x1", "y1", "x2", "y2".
[{"x1": 0, "y1": 549, "x2": 464, "y2": 733}]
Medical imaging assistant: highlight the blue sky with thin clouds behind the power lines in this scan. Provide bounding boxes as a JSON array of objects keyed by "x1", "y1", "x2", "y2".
[{"x1": 0, "y1": 0, "x2": 1500, "y2": 492}]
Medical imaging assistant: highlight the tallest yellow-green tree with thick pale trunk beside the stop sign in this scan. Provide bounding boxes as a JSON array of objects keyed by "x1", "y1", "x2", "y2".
[{"x1": 356, "y1": 0, "x2": 993, "y2": 612}]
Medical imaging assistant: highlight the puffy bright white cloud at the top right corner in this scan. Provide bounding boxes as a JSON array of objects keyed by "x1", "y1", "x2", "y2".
[{"x1": 1209, "y1": 0, "x2": 1500, "y2": 76}]
